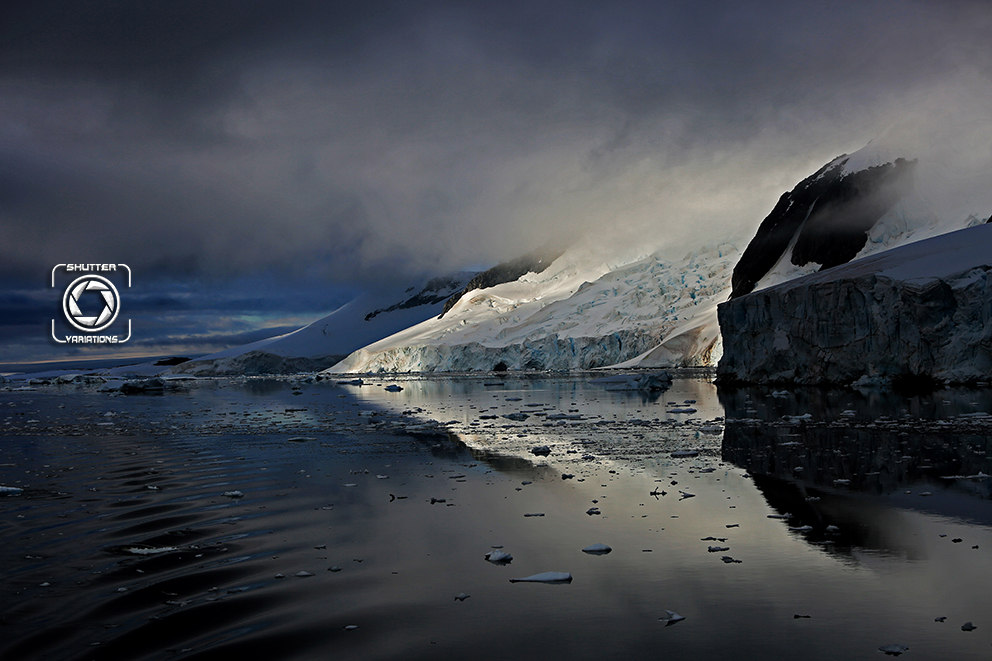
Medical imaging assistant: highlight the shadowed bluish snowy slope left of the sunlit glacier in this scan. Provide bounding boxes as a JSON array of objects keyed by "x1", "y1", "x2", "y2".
[{"x1": 169, "y1": 272, "x2": 476, "y2": 376}]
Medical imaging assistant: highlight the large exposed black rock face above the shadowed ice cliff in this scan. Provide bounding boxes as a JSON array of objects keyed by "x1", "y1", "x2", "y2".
[{"x1": 730, "y1": 155, "x2": 916, "y2": 298}]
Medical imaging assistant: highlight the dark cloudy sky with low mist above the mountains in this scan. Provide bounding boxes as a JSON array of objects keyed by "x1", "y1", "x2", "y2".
[{"x1": 0, "y1": 0, "x2": 992, "y2": 364}]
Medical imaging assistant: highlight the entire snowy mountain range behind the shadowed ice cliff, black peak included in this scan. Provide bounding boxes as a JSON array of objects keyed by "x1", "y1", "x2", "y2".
[{"x1": 167, "y1": 138, "x2": 983, "y2": 374}]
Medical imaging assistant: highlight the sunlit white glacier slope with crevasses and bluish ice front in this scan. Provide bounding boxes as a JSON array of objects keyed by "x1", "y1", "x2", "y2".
[{"x1": 328, "y1": 244, "x2": 739, "y2": 372}]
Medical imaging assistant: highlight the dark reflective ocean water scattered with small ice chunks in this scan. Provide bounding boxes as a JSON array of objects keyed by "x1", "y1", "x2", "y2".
[{"x1": 0, "y1": 377, "x2": 992, "y2": 661}]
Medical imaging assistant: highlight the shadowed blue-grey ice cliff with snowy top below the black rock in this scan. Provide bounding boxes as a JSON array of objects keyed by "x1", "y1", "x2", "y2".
[{"x1": 717, "y1": 224, "x2": 992, "y2": 384}]
